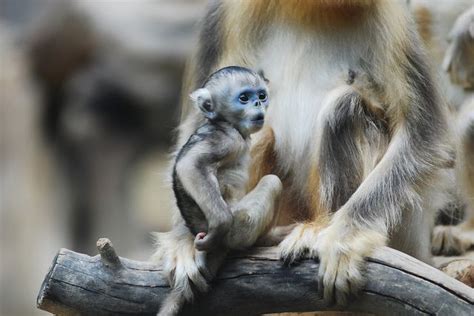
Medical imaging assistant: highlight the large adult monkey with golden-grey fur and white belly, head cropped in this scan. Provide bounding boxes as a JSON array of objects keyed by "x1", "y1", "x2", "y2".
[{"x1": 155, "y1": 0, "x2": 452, "y2": 304}]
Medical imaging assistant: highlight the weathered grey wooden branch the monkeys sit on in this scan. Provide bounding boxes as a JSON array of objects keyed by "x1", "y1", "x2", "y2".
[{"x1": 37, "y1": 240, "x2": 474, "y2": 315}]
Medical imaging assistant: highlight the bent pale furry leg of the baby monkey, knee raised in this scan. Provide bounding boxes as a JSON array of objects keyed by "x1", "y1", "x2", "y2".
[{"x1": 226, "y1": 175, "x2": 282, "y2": 249}]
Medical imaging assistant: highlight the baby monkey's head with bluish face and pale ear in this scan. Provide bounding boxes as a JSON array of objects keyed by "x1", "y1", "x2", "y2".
[{"x1": 191, "y1": 66, "x2": 268, "y2": 137}]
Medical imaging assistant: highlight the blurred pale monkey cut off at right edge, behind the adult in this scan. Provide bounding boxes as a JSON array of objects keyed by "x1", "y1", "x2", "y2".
[{"x1": 410, "y1": 0, "x2": 474, "y2": 255}]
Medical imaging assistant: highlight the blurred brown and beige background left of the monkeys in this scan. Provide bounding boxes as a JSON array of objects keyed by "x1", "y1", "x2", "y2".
[{"x1": 0, "y1": 0, "x2": 204, "y2": 315}]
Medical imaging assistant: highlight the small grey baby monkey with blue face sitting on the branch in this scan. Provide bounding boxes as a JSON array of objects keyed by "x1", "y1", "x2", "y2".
[{"x1": 155, "y1": 66, "x2": 282, "y2": 316}]
